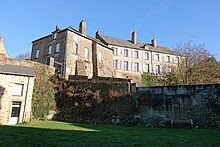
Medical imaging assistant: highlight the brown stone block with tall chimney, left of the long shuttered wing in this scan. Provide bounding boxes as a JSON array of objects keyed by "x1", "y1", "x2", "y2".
[{"x1": 31, "y1": 21, "x2": 113, "y2": 78}]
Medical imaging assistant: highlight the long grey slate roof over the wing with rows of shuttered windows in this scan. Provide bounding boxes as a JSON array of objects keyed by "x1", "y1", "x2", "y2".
[{"x1": 97, "y1": 33, "x2": 178, "y2": 55}]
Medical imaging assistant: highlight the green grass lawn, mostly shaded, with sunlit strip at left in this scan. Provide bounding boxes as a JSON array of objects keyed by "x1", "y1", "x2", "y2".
[{"x1": 0, "y1": 121, "x2": 220, "y2": 147}]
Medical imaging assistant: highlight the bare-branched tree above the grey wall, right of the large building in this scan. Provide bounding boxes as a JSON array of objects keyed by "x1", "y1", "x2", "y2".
[{"x1": 176, "y1": 42, "x2": 220, "y2": 84}]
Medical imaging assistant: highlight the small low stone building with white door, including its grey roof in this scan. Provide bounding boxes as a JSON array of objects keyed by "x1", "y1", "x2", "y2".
[{"x1": 0, "y1": 64, "x2": 34, "y2": 125}]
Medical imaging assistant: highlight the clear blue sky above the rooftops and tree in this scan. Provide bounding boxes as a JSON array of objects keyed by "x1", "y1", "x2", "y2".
[{"x1": 0, "y1": 0, "x2": 220, "y2": 61}]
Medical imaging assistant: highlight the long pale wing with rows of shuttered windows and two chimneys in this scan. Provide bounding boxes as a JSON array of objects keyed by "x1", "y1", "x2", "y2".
[{"x1": 96, "y1": 31, "x2": 180, "y2": 84}]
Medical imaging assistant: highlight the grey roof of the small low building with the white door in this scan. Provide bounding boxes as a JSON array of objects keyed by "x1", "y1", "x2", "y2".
[{"x1": 0, "y1": 64, "x2": 34, "y2": 77}]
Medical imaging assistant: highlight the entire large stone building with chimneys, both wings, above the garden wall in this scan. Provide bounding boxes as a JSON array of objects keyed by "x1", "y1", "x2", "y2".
[{"x1": 31, "y1": 21, "x2": 180, "y2": 85}]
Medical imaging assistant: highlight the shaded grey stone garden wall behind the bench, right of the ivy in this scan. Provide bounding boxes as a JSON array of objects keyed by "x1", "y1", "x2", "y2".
[{"x1": 132, "y1": 84, "x2": 220, "y2": 127}]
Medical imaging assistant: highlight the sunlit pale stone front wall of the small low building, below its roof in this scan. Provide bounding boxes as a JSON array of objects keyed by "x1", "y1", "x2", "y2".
[{"x1": 0, "y1": 65, "x2": 34, "y2": 124}]
